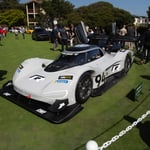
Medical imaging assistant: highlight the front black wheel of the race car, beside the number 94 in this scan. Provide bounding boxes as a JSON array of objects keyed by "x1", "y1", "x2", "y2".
[{"x1": 75, "y1": 73, "x2": 93, "y2": 104}]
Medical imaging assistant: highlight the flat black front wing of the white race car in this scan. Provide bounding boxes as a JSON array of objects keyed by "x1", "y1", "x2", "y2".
[{"x1": 0, "y1": 81, "x2": 83, "y2": 124}]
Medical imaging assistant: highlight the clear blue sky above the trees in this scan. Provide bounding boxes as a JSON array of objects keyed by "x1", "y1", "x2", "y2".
[{"x1": 20, "y1": 0, "x2": 150, "y2": 16}]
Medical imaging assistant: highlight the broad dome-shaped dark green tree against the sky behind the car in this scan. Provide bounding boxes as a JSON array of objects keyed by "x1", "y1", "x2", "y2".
[{"x1": 67, "y1": 2, "x2": 134, "y2": 33}]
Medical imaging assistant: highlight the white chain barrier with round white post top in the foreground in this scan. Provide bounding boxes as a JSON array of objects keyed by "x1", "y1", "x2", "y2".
[{"x1": 86, "y1": 110, "x2": 150, "y2": 150}]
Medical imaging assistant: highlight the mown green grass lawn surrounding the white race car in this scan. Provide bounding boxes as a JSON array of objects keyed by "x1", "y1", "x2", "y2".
[{"x1": 0, "y1": 33, "x2": 150, "y2": 150}]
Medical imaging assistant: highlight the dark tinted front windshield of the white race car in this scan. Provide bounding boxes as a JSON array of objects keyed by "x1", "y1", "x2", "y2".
[{"x1": 45, "y1": 53, "x2": 86, "y2": 72}]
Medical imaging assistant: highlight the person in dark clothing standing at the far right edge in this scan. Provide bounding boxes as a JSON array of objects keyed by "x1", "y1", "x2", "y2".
[{"x1": 141, "y1": 25, "x2": 150, "y2": 64}]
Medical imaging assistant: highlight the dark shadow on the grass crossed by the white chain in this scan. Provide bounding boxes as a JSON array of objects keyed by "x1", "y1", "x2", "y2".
[{"x1": 124, "y1": 116, "x2": 150, "y2": 147}]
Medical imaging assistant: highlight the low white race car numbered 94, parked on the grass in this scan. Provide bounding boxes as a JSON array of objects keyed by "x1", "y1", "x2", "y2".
[{"x1": 2, "y1": 44, "x2": 134, "y2": 123}]
